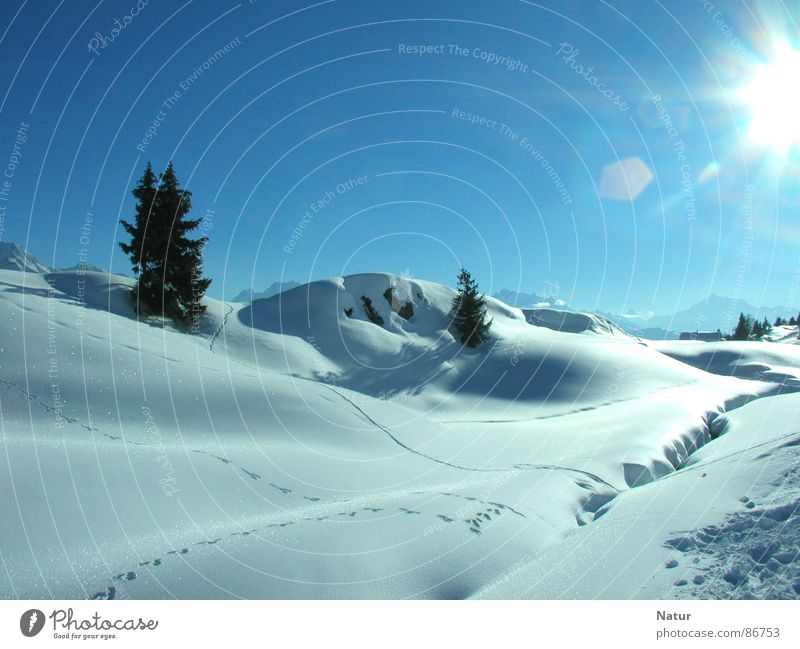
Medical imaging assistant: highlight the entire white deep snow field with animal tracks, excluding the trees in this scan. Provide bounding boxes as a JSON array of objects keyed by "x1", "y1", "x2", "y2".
[{"x1": 0, "y1": 270, "x2": 800, "y2": 599}]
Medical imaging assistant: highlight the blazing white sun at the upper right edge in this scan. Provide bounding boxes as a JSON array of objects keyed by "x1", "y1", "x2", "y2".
[{"x1": 740, "y1": 46, "x2": 800, "y2": 154}]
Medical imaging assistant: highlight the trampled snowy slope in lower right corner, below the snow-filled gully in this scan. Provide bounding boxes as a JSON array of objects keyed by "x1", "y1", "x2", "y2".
[{"x1": 475, "y1": 394, "x2": 800, "y2": 599}]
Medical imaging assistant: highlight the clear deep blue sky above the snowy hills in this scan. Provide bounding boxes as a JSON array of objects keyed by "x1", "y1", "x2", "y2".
[{"x1": 0, "y1": 0, "x2": 800, "y2": 312}]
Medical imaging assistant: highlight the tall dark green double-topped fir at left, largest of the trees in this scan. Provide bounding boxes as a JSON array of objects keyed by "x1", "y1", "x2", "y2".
[{"x1": 120, "y1": 162, "x2": 211, "y2": 326}]
